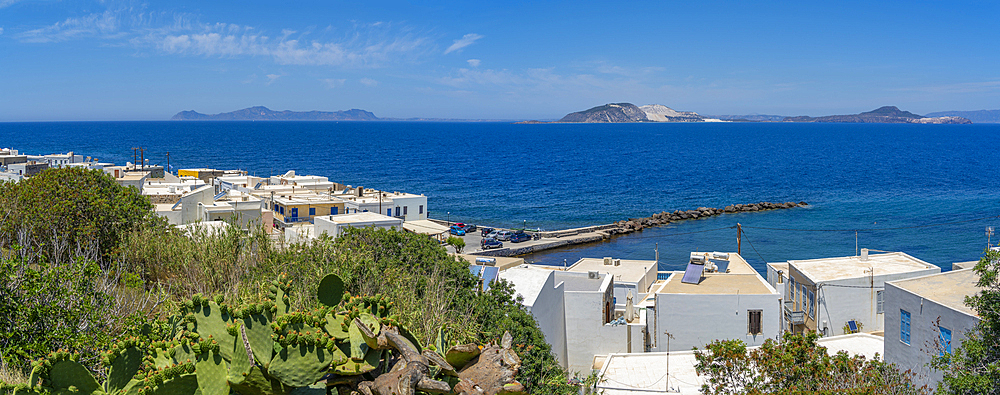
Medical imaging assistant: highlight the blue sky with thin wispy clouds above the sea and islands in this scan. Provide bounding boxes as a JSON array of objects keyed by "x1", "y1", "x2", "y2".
[{"x1": 0, "y1": 0, "x2": 1000, "y2": 121}]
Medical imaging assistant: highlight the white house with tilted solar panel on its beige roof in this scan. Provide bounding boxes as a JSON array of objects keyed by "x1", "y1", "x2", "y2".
[{"x1": 646, "y1": 252, "x2": 781, "y2": 351}]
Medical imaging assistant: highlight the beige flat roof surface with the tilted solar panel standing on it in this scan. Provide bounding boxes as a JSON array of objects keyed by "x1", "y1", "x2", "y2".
[{"x1": 654, "y1": 271, "x2": 776, "y2": 295}]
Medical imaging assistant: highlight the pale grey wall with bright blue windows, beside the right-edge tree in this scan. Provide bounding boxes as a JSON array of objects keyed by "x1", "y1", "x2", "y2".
[{"x1": 885, "y1": 284, "x2": 979, "y2": 389}]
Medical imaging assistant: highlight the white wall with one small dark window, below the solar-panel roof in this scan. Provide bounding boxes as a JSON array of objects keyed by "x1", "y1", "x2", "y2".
[{"x1": 653, "y1": 294, "x2": 782, "y2": 352}]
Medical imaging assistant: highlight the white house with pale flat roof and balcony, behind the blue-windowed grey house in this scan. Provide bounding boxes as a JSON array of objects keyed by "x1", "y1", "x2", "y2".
[{"x1": 782, "y1": 249, "x2": 941, "y2": 336}]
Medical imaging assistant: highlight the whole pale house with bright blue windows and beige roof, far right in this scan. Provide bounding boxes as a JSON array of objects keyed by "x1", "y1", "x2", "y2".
[{"x1": 884, "y1": 269, "x2": 980, "y2": 388}]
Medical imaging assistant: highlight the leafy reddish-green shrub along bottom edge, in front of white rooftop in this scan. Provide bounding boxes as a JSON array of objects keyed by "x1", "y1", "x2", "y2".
[{"x1": 695, "y1": 333, "x2": 927, "y2": 394}]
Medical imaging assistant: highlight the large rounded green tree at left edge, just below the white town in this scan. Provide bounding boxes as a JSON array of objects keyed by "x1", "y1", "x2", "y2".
[{"x1": 0, "y1": 168, "x2": 156, "y2": 264}]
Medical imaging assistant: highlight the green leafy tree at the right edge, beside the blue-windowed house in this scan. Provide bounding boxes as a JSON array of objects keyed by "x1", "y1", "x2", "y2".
[{"x1": 932, "y1": 250, "x2": 1000, "y2": 394}]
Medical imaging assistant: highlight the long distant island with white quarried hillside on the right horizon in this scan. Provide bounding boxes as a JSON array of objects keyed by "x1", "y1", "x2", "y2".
[{"x1": 544, "y1": 103, "x2": 972, "y2": 124}]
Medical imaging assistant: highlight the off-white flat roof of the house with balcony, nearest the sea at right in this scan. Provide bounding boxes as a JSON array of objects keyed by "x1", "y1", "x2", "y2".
[{"x1": 788, "y1": 252, "x2": 936, "y2": 282}]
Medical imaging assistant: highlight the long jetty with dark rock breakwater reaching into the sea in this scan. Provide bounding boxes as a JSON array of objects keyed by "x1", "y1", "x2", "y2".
[{"x1": 468, "y1": 202, "x2": 808, "y2": 256}]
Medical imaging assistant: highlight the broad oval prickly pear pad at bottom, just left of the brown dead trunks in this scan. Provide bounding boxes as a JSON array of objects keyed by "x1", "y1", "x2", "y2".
[{"x1": 267, "y1": 345, "x2": 332, "y2": 387}]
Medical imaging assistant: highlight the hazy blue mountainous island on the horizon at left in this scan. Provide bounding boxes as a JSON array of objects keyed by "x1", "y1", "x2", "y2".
[{"x1": 170, "y1": 106, "x2": 379, "y2": 121}]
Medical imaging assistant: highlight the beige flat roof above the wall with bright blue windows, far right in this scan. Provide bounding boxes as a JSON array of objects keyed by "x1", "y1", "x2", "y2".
[{"x1": 889, "y1": 269, "x2": 982, "y2": 316}]
